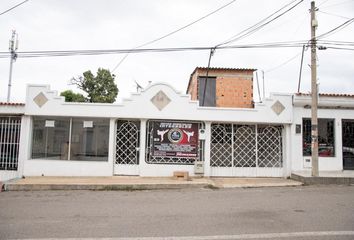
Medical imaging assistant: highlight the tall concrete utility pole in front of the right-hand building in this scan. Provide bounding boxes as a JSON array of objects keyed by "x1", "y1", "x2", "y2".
[{"x1": 310, "y1": 1, "x2": 319, "y2": 177}]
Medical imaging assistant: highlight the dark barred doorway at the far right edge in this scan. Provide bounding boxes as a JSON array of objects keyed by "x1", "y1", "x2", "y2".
[{"x1": 342, "y1": 120, "x2": 354, "y2": 170}]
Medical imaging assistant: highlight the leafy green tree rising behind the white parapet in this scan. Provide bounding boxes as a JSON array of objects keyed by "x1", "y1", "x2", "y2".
[{"x1": 65, "y1": 68, "x2": 118, "y2": 103}]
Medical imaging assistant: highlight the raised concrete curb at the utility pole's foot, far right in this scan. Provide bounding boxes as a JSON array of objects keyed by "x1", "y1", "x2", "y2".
[{"x1": 291, "y1": 173, "x2": 354, "y2": 185}]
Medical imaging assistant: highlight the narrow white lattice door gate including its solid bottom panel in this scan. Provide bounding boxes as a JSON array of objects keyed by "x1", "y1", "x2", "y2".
[{"x1": 114, "y1": 120, "x2": 140, "y2": 175}]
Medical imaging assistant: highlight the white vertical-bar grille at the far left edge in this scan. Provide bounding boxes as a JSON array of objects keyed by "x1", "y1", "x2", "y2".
[{"x1": 0, "y1": 117, "x2": 21, "y2": 170}]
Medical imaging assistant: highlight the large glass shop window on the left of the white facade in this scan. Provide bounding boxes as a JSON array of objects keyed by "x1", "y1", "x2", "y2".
[{"x1": 32, "y1": 117, "x2": 109, "y2": 161}]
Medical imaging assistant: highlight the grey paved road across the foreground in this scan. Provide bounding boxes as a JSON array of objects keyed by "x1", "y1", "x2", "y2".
[{"x1": 0, "y1": 186, "x2": 354, "y2": 240}]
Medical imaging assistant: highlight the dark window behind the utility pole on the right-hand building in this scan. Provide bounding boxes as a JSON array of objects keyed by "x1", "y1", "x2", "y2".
[{"x1": 302, "y1": 118, "x2": 334, "y2": 157}]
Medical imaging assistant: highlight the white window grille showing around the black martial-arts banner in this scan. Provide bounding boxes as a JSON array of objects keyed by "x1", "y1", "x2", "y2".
[{"x1": 146, "y1": 120, "x2": 204, "y2": 165}]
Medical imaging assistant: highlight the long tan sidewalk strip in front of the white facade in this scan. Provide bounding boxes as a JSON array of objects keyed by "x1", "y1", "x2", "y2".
[{"x1": 3, "y1": 176, "x2": 302, "y2": 191}]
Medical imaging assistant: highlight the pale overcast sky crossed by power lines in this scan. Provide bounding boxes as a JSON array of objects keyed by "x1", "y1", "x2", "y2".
[{"x1": 0, "y1": 0, "x2": 354, "y2": 102}]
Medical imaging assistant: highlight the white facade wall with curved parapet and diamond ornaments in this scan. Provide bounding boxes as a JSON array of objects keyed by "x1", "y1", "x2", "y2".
[{"x1": 22, "y1": 83, "x2": 292, "y2": 176}]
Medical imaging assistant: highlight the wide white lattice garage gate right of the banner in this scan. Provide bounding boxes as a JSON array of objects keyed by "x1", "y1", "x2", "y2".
[{"x1": 210, "y1": 124, "x2": 283, "y2": 177}]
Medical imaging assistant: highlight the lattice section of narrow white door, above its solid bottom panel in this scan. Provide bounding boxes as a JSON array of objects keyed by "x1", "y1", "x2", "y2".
[{"x1": 115, "y1": 120, "x2": 140, "y2": 165}]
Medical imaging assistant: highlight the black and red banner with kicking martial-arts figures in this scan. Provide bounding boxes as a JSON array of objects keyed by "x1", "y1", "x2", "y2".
[{"x1": 152, "y1": 121, "x2": 199, "y2": 158}]
